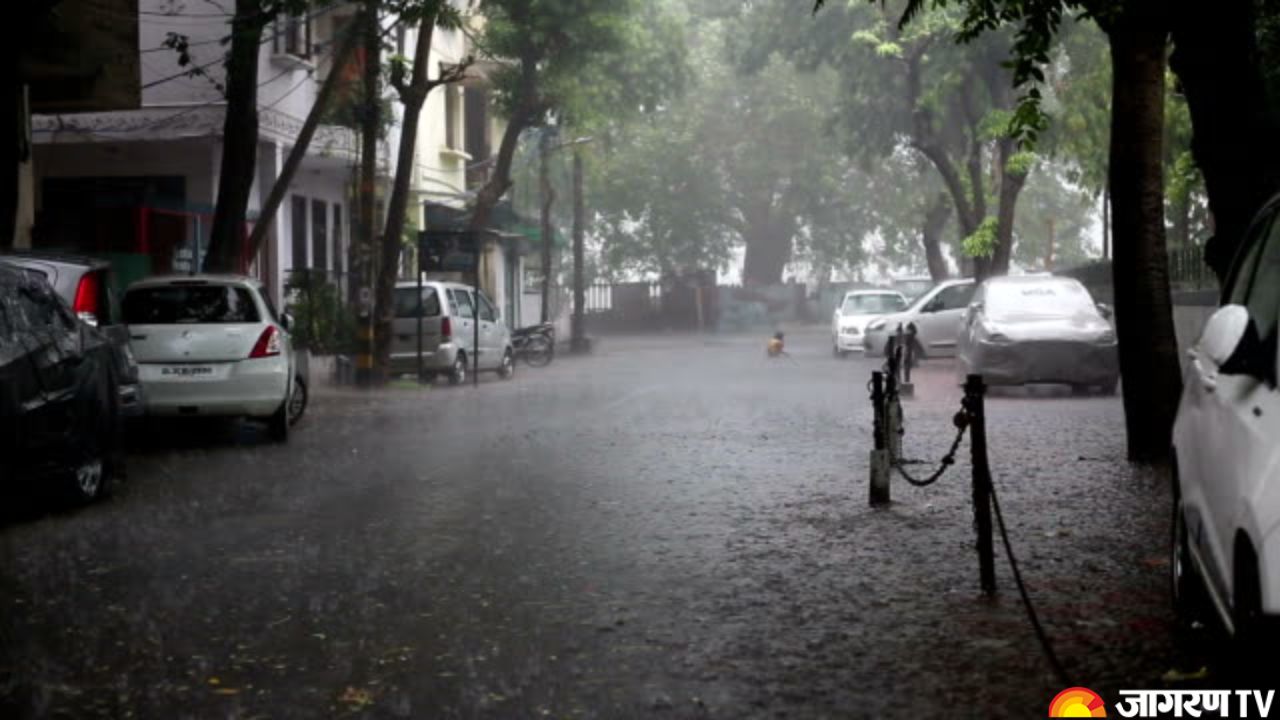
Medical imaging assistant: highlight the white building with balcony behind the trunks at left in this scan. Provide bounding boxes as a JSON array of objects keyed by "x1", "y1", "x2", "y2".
[{"x1": 32, "y1": 0, "x2": 373, "y2": 299}]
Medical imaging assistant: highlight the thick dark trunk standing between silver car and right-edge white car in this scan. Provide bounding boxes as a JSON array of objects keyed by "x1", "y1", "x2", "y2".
[{"x1": 1107, "y1": 11, "x2": 1181, "y2": 461}]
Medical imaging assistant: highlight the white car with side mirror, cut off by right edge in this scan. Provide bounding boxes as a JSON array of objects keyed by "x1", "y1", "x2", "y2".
[{"x1": 1170, "y1": 194, "x2": 1280, "y2": 638}]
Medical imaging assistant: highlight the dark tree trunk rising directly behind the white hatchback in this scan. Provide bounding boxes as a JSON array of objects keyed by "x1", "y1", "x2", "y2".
[{"x1": 204, "y1": 0, "x2": 269, "y2": 273}]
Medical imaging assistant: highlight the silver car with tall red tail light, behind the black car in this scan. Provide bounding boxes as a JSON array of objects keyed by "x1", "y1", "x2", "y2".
[{"x1": 0, "y1": 250, "x2": 145, "y2": 418}]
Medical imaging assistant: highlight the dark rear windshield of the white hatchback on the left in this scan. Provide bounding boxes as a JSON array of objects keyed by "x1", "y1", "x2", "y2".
[{"x1": 124, "y1": 284, "x2": 261, "y2": 325}]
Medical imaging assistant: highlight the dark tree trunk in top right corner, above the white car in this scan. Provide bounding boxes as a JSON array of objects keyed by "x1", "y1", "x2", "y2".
[{"x1": 1169, "y1": 0, "x2": 1280, "y2": 281}]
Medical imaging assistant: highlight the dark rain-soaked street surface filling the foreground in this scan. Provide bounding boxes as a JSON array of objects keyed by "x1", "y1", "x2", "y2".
[{"x1": 0, "y1": 331, "x2": 1239, "y2": 719}]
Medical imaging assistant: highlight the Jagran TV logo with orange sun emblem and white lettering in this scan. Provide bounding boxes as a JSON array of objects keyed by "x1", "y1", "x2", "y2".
[{"x1": 1048, "y1": 688, "x2": 1275, "y2": 717}]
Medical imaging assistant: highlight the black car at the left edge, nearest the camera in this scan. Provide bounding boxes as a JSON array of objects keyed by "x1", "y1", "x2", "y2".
[{"x1": 0, "y1": 261, "x2": 120, "y2": 502}]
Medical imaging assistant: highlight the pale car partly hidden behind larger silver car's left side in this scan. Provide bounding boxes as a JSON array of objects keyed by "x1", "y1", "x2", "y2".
[{"x1": 863, "y1": 278, "x2": 974, "y2": 357}]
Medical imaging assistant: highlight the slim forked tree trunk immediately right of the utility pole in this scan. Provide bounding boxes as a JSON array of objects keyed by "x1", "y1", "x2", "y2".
[{"x1": 374, "y1": 14, "x2": 435, "y2": 382}]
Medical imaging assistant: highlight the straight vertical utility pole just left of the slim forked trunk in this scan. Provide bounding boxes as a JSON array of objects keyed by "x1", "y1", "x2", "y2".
[{"x1": 353, "y1": 0, "x2": 381, "y2": 384}]
